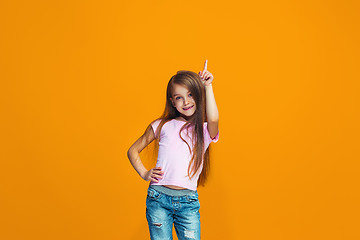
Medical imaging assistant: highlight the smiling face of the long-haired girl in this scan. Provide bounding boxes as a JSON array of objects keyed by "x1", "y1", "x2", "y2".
[{"x1": 170, "y1": 84, "x2": 196, "y2": 119}]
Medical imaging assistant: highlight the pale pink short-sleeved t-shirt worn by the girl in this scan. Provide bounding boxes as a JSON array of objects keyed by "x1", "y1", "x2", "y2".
[{"x1": 150, "y1": 119, "x2": 219, "y2": 191}]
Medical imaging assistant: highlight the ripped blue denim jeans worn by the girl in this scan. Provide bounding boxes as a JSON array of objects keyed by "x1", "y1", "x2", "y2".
[{"x1": 146, "y1": 186, "x2": 200, "y2": 240}]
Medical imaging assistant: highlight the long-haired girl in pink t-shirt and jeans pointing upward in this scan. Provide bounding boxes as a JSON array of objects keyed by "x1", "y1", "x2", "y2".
[{"x1": 127, "y1": 60, "x2": 219, "y2": 240}]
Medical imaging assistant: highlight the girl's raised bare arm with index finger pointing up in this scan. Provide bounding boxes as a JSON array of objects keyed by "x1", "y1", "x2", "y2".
[{"x1": 199, "y1": 60, "x2": 219, "y2": 138}]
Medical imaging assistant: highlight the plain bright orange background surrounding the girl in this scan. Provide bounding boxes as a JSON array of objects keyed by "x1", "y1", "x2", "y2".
[{"x1": 0, "y1": 0, "x2": 360, "y2": 240}]
